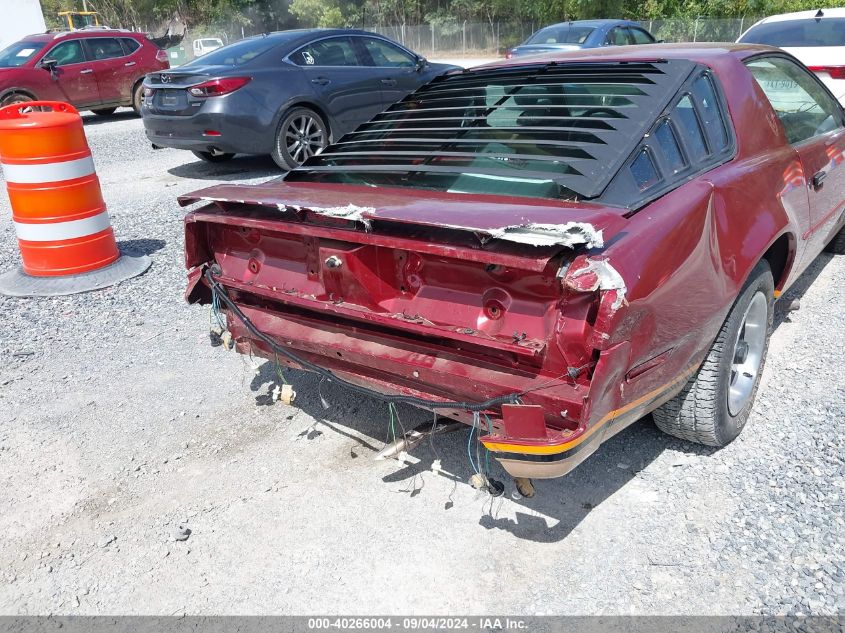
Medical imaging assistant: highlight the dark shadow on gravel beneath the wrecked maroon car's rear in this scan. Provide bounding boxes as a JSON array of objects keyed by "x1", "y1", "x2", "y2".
[{"x1": 250, "y1": 362, "x2": 664, "y2": 543}]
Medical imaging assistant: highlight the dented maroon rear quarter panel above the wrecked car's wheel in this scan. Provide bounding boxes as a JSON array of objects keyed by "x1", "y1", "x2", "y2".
[{"x1": 598, "y1": 53, "x2": 806, "y2": 410}]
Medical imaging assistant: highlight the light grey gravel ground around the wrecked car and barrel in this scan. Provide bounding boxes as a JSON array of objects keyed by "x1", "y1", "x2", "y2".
[{"x1": 0, "y1": 112, "x2": 845, "y2": 614}]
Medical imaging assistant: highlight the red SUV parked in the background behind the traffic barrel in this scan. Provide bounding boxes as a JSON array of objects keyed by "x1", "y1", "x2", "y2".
[{"x1": 0, "y1": 29, "x2": 170, "y2": 114}]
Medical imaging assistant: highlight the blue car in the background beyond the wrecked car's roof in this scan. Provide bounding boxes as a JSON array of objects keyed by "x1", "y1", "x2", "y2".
[{"x1": 505, "y1": 20, "x2": 657, "y2": 59}]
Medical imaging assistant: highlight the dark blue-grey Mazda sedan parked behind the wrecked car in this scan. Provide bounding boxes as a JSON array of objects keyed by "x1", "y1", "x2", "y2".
[{"x1": 142, "y1": 29, "x2": 457, "y2": 169}]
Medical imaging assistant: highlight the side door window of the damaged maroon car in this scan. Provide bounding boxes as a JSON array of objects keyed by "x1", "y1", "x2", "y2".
[{"x1": 746, "y1": 57, "x2": 843, "y2": 143}]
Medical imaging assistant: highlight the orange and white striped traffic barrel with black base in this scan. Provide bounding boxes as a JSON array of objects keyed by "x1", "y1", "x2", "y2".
[{"x1": 0, "y1": 101, "x2": 150, "y2": 296}]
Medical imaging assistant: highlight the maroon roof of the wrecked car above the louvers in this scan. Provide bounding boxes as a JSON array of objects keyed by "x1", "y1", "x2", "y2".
[{"x1": 474, "y1": 42, "x2": 782, "y2": 68}]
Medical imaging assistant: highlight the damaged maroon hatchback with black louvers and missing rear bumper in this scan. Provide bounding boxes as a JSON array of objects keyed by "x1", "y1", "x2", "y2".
[{"x1": 181, "y1": 44, "x2": 845, "y2": 485}]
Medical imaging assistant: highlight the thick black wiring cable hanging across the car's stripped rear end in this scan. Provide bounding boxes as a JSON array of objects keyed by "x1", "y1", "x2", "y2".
[{"x1": 205, "y1": 268, "x2": 522, "y2": 412}]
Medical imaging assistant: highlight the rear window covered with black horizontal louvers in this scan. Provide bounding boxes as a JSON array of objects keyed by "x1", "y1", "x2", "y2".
[{"x1": 287, "y1": 60, "x2": 695, "y2": 198}]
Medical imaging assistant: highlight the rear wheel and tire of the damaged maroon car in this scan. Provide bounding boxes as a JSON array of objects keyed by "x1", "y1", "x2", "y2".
[{"x1": 652, "y1": 261, "x2": 774, "y2": 447}]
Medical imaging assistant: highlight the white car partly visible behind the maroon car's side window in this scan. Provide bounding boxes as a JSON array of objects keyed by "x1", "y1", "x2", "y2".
[{"x1": 737, "y1": 8, "x2": 845, "y2": 105}]
